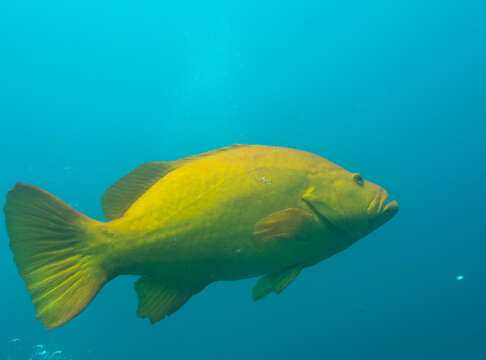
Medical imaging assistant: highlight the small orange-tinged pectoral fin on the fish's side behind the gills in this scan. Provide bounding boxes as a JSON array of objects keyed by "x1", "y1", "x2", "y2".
[{"x1": 253, "y1": 208, "x2": 314, "y2": 241}]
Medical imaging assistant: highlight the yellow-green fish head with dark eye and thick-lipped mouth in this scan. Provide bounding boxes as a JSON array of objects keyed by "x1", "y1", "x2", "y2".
[{"x1": 302, "y1": 166, "x2": 398, "y2": 241}]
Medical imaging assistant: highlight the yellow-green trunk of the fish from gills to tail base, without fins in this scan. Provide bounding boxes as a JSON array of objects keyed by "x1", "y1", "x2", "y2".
[{"x1": 108, "y1": 146, "x2": 349, "y2": 282}]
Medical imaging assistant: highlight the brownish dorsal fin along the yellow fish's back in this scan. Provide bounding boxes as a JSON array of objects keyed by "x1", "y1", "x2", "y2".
[{"x1": 101, "y1": 144, "x2": 247, "y2": 220}]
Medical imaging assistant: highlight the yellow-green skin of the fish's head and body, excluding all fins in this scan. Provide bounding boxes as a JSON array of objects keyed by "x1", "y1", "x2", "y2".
[{"x1": 102, "y1": 146, "x2": 397, "y2": 289}]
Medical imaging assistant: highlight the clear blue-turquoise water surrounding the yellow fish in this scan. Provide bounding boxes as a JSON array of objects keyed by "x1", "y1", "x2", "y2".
[{"x1": 0, "y1": 0, "x2": 486, "y2": 360}]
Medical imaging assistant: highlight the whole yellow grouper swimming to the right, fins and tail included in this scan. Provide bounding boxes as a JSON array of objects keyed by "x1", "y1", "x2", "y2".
[{"x1": 4, "y1": 145, "x2": 398, "y2": 329}]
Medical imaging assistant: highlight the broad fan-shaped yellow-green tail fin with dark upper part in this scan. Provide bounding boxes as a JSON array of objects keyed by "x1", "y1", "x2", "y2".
[{"x1": 4, "y1": 183, "x2": 108, "y2": 329}]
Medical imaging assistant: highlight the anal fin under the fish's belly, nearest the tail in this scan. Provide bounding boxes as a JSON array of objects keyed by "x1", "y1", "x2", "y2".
[{"x1": 135, "y1": 277, "x2": 204, "y2": 324}]
